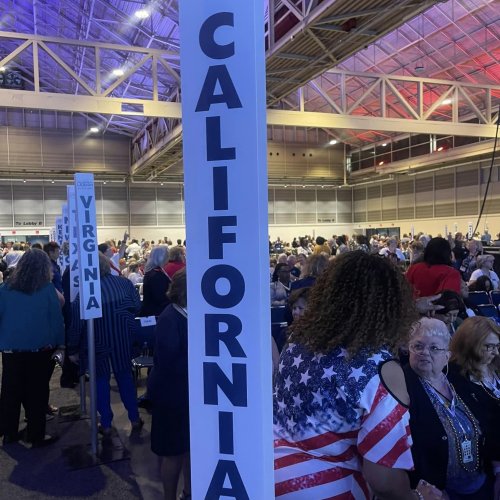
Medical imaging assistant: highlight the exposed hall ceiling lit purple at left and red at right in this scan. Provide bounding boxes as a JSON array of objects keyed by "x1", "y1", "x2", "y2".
[{"x1": 0, "y1": 0, "x2": 500, "y2": 185}]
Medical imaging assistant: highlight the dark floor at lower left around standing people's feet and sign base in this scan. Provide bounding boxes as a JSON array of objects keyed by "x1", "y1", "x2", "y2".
[{"x1": 0, "y1": 361, "x2": 163, "y2": 500}]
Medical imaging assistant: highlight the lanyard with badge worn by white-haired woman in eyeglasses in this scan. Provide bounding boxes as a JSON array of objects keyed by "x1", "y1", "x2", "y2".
[{"x1": 421, "y1": 378, "x2": 481, "y2": 472}]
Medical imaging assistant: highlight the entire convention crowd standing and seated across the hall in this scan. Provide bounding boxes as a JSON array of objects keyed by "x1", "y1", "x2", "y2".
[{"x1": 0, "y1": 231, "x2": 500, "y2": 500}]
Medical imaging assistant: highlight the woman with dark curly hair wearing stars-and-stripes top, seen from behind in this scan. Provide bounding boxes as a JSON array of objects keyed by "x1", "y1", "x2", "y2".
[{"x1": 274, "y1": 251, "x2": 441, "y2": 500}]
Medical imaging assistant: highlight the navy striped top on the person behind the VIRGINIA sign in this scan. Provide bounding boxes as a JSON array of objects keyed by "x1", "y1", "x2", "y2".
[{"x1": 68, "y1": 274, "x2": 141, "y2": 377}]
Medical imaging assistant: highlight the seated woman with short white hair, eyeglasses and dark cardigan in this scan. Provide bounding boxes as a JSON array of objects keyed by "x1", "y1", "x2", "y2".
[{"x1": 404, "y1": 317, "x2": 497, "y2": 500}]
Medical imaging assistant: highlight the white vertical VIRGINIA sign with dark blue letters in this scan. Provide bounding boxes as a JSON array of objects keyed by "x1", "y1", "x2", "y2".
[{"x1": 75, "y1": 173, "x2": 102, "y2": 319}]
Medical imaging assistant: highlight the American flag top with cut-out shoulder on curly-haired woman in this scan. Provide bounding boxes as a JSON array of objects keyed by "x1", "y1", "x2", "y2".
[{"x1": 273, "y1": 344, "x2": 413, "y2": 500}]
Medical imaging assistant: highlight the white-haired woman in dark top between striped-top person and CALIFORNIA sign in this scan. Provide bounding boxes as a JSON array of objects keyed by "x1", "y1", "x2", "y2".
[{"x1": 139, "y1": 245, "x2": 170, "y2": 316}]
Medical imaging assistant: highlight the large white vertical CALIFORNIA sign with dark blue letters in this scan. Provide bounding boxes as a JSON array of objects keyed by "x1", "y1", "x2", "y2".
[{"x1": 180, "y1": 0, "x2": 274, "y2": 500}]
